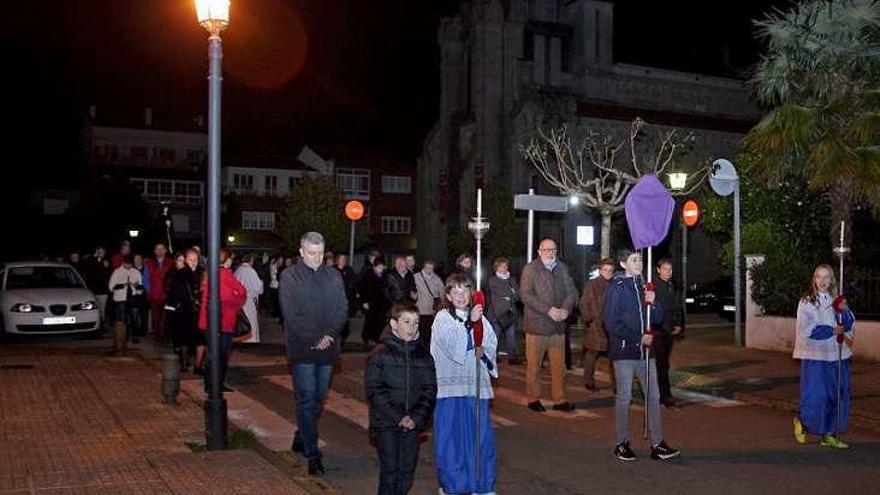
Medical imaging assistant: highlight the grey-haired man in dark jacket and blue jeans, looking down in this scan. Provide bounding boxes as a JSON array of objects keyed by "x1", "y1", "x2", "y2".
[{"x1": 279, "y1": 232, "x2": 348, "y2": 474}]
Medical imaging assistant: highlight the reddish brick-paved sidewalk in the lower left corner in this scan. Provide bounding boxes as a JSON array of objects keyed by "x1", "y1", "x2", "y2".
[{"x1": 0, "y1": 340, "x2": 321, "y2": 495}]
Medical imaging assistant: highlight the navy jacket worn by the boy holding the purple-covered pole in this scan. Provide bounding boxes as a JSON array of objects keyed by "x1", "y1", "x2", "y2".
[{"x1": 602, "y1": 276, "x2": 663, "y2": 361}]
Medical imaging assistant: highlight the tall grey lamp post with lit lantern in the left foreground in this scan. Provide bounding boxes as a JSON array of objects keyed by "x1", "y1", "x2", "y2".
[{"x1": 196, "y1": 0, "x2": 229, "y2": 450}]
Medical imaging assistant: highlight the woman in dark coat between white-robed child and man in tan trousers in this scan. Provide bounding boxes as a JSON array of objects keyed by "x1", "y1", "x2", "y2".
[{"x1": 486, "y1": 258, "x2": 520, "y2": 364}]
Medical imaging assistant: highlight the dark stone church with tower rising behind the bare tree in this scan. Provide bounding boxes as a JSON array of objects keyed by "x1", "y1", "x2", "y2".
[{"x1": 418, "y1": 0, "x2": 761, "y2": 272}]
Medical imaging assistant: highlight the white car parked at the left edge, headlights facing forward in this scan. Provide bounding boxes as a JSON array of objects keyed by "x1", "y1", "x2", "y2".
[{"x1": 0, "y1": 261, "x2": 101, "y2": 335}]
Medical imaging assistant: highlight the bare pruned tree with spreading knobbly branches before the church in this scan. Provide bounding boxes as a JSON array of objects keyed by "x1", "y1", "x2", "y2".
[{"x1": 520, "y1": 118, "x2": 709, "y2": 258}]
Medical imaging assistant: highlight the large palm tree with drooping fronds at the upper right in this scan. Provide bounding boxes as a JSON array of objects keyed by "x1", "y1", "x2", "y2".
[{"x1": 744, "y1": 0, "x2": 880, "y2": 248}]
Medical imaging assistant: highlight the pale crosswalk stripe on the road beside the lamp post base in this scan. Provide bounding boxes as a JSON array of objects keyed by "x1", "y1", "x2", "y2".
[{"x1": 180, "y1": 380, "x2": 327, "y2": 452}]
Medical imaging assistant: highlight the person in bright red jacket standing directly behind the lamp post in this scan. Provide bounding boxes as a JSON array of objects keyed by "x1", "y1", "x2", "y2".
[{"x1": 199, "y1": 248, "x2": 247, "y2": 392}]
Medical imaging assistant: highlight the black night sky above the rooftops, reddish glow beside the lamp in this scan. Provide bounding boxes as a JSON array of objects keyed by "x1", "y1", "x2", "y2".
[{"x1": 0, "y1": 0, "x2": 789, "y2": 183}]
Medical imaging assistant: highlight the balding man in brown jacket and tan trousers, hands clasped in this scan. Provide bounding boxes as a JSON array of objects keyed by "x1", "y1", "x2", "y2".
[{"x1": 520, "y1": 237, "x2": 577, "y2": 412}]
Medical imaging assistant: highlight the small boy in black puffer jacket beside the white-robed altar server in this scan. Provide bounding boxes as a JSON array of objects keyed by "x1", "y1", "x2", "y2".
[{"x1": 364, "y1": 302, "x2": 437, "y2": 495}]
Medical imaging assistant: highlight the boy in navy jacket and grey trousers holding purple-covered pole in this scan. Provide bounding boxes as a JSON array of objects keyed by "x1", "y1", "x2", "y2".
[{"x1": 602, "y1": 249, "x2": 680, "y2": 461}]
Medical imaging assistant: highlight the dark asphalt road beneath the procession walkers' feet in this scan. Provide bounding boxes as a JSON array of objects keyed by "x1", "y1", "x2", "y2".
[{"x1": 215, "y1": 318, "x2": 880, "y2": 495}]
